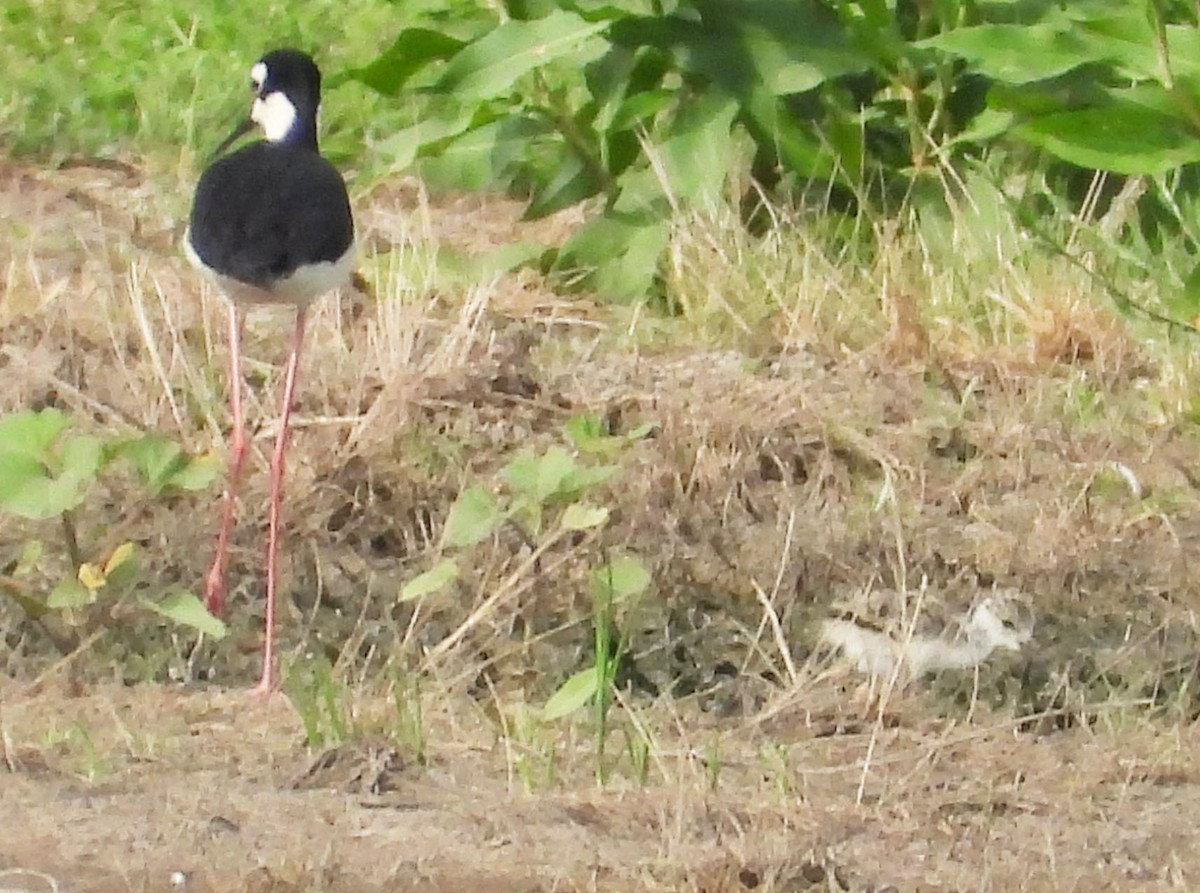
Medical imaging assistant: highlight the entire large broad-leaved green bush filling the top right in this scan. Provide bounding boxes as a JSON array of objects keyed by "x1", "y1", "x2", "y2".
[{"x1": 347, "y1": 0, "x2": 1200, "y2": 320}]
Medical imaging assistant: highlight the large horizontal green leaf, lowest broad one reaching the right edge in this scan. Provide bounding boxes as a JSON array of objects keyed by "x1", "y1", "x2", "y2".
[{"x1": 1013, "y1": 103, "x2": 1200, "y2": 176}]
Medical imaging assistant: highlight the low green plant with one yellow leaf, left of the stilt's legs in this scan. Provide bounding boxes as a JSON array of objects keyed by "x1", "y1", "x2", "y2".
[{"x1": 0, "y1": 408, "x2": 226, "y2": 649}]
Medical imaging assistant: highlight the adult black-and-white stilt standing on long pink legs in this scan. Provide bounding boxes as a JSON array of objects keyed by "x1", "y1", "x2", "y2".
[{"x1": 184, "y1": 49, "x2": 354, "y2": 691}]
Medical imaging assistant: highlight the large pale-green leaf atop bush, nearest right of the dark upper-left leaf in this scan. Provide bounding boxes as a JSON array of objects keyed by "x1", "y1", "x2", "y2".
[{"x1": 434, "y1": 11, "x2": 607, "y2": 101}]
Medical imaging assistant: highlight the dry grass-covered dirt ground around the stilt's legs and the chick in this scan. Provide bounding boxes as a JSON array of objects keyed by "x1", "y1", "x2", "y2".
[{"x1": 0, "y1": 166, "x2": 1200, "y2": 893}]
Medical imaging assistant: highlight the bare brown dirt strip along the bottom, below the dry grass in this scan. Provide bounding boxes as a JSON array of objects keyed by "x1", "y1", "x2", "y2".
[{"x1": 0, "y1": 683, "x2": 1200, "y2": 893}]
